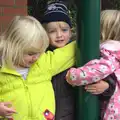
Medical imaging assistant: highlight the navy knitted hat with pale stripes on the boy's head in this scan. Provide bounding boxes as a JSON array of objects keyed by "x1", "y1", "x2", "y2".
[{"x1": 41, "y1": 1, "x2": 72, "y2": 27}]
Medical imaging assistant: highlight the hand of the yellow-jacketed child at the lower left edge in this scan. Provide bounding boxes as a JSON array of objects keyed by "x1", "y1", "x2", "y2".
[{"x1": 0, "y1": 102, "x2": 16, "y2": 117}]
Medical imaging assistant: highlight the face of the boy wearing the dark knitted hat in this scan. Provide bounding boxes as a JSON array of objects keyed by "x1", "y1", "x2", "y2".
[{"x1": 46, "y1": 22, "x2": 71, "y2": 48}]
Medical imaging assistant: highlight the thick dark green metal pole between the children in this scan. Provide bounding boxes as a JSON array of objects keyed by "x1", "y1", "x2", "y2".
[{"x1": 75, "y1": 0, "x2": 100, "y2": 120}]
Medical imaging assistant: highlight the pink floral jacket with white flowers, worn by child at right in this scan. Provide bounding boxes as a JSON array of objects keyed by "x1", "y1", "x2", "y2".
[{"x1": 67, "y1": 40, "x2": 120, "y2": 120}]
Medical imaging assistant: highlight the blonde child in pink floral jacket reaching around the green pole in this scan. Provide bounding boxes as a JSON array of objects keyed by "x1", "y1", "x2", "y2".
[{"x1": 66, "y1": 10, "x2": 120, "y2": 120}]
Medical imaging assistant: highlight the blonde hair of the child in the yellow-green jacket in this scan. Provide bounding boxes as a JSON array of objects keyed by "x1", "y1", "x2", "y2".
[{"x1": 0, "y1": 16, "x2": 49, "y2": 67}]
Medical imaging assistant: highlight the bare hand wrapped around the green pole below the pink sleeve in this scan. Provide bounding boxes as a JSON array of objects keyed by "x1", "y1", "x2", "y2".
[{"x1": 85, "y1": 80, "x2": 109, "y2": 94}]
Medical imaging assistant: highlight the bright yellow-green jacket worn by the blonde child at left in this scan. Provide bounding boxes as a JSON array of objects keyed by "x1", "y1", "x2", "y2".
[{"x1": 0, "y1": 42, "x2": 75, "y2": 120}]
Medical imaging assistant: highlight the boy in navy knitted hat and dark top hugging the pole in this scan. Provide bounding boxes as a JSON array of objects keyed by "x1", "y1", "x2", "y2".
[{"x1": 42, "y1": 1, "x2": 114, "y2": 120}]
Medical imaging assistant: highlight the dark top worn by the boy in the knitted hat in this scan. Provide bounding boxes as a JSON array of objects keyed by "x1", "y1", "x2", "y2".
[{"x1": 48, "y1": 47, "x2": 75, "y2": 120}]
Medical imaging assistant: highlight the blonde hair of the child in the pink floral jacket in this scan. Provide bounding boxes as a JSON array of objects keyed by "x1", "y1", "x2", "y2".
[{"x1": 100, "y1": 10, "x2": 120, "y2": 42}]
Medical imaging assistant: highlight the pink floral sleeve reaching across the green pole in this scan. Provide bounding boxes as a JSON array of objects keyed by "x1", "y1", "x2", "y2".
[{"x1": 67, "y1": 57, "x2": 119, "y2": 86}]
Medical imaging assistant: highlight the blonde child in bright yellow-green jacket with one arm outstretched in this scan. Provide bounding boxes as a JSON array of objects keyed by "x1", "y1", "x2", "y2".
[{"x1": 0, "y1": 16, "x2": 75, "y2": 120}]
